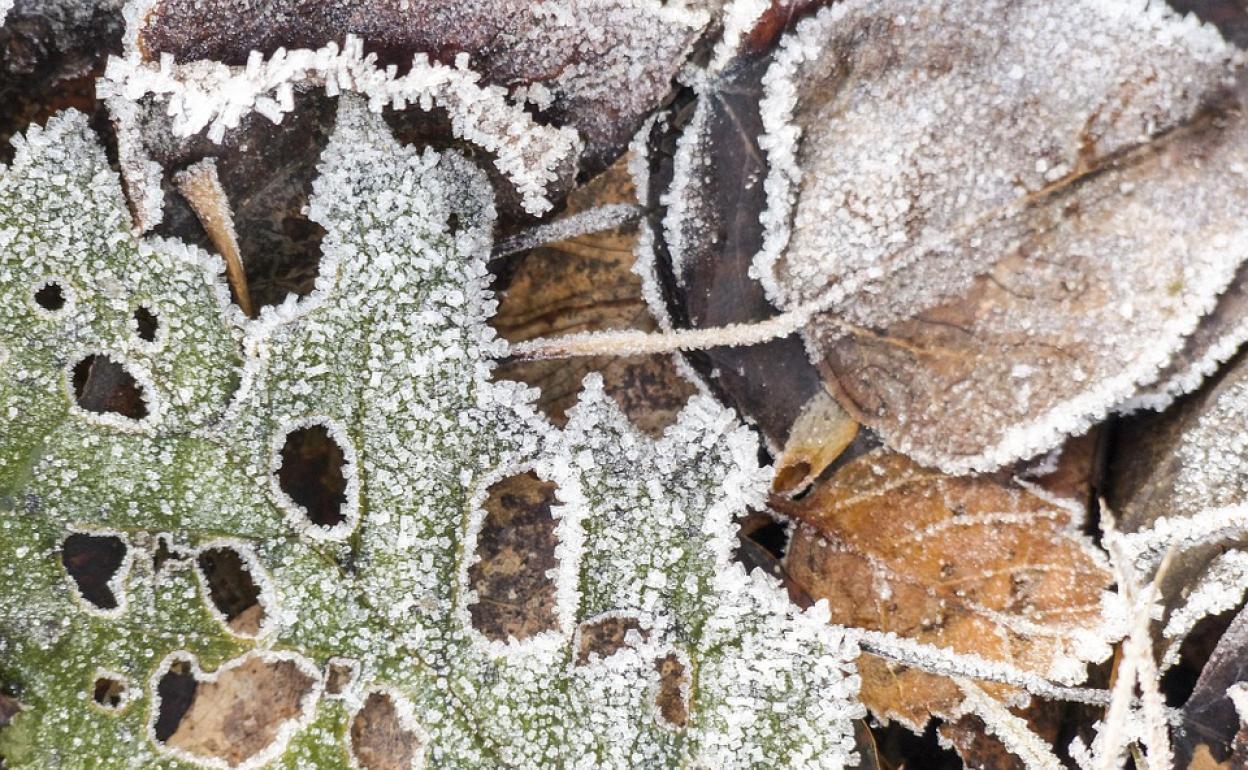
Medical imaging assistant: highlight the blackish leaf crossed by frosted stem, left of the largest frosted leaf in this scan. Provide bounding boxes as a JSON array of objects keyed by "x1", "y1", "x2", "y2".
[{"x1": 643, "y1": 43, "x2": 824, "y2": 451}]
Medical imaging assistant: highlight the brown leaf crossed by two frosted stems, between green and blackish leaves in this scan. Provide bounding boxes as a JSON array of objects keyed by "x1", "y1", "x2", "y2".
[{"x1": 490, "y1": 152, "x2": 695, "y2": 436}]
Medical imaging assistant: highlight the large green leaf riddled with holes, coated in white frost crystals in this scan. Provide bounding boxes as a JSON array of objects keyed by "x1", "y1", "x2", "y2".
[{"x1": 0, "y1": 97, "x2": 861, "y2": 768}]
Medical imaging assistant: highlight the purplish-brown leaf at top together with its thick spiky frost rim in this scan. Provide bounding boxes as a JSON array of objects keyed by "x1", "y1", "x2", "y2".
[{"x1": 101, "y1": 0, "x2": 706, "y2": 228}]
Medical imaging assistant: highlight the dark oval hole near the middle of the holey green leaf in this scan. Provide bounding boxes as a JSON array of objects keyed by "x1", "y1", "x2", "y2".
[{"x1": 277, "y1": 426, "x2": 347, "y2": 527}]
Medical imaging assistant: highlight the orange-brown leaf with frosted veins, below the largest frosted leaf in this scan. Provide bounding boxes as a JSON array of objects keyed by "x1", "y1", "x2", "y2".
[{"x1": 773, "y1": 451, "x2": 1112, "y2": 730}]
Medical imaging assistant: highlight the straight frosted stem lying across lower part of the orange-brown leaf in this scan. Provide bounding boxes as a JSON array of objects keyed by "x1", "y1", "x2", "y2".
[{"x1": 847, "y1": 629, "x2": 1109, "y2": 706}]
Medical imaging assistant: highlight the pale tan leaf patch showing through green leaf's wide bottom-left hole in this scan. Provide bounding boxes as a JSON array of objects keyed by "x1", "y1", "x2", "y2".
[{"x1": 165, "y1": 655, "x2": 314, "y2": 766}]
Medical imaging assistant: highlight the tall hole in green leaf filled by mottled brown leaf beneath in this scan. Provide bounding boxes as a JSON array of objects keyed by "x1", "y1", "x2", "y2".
[{"x1": 468, "y1": 472, "x2": 558, "y2": 640}]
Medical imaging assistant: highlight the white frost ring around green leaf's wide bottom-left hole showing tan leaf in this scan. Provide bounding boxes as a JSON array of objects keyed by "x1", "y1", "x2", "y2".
[{"x1": 146, "y1": 650, "x2": 323, "y2": 770}]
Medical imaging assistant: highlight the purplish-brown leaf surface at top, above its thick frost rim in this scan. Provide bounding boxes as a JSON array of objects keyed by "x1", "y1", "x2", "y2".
[{"x1": 137, "y1": 0, "x2": 705, "y2": 172}]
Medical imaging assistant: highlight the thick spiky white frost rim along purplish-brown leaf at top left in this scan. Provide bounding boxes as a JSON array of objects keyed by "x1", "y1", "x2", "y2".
[{"x1": 97, "y1": 34, "x2": 584, "y2": 217}]
